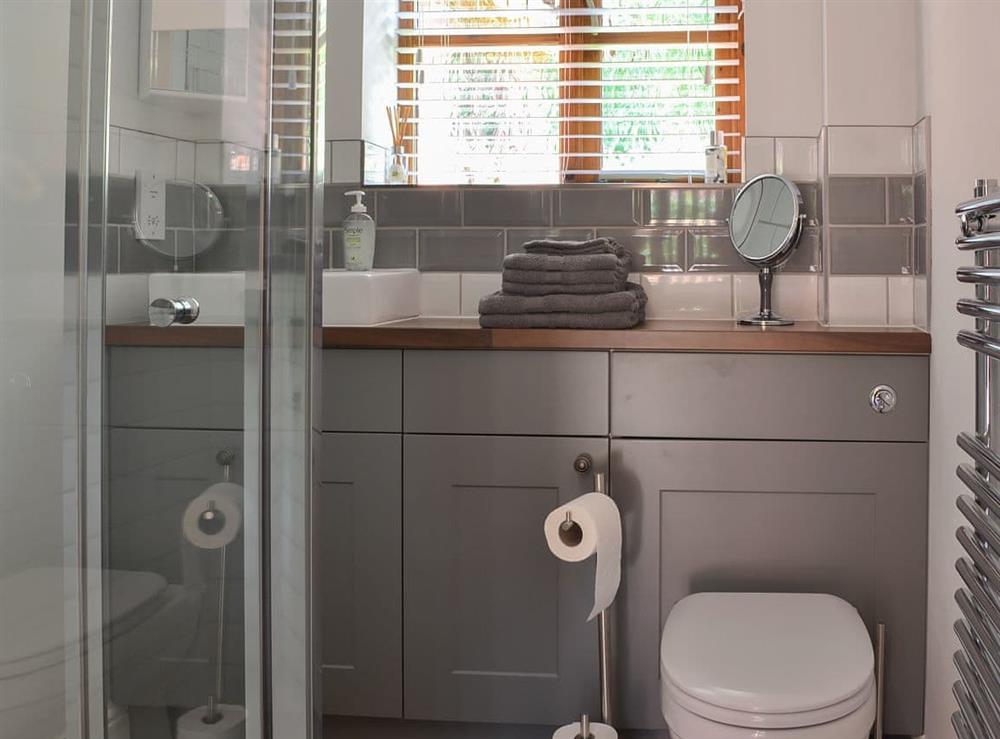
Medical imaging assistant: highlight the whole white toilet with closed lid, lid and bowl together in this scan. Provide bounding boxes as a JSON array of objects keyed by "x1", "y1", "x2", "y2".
[{"x1": 660, "y1": 593, "x2": 876, "y2": 739}]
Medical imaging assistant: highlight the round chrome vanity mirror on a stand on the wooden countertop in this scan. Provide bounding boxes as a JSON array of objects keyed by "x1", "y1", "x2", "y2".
[{"x1": 729, "y1": 174, "x2": 804, "y2": 326}]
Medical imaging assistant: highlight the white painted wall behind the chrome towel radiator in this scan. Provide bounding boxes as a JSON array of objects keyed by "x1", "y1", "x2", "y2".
[{"x1": 918, "y1": 0, "x2": 1000, "y2": 739}]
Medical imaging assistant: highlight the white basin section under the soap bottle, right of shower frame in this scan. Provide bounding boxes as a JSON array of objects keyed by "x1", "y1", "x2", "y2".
[{"x1": 323, "y1": 269, "x2": 420, "y2": 326}]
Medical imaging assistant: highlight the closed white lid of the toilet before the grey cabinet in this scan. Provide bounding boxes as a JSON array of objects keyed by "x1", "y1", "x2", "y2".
[{"x1": 660, "y1": 593, "x2": 874, "y2": 714}]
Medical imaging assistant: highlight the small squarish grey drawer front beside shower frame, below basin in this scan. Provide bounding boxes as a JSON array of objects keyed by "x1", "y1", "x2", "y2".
[{"x1": 322, "y1": 349, "x2": 403, "y2": 431}]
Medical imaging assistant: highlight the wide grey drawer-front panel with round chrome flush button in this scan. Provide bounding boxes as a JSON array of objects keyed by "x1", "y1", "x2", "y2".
[{"x1": 611, "y1": 352, "x2": 928, "y2": 441}]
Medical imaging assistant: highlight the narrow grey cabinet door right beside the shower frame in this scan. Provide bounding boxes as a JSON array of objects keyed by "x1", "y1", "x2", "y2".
[{"x1": 318, "y1": 434, "x2": 403, "y2": 718}]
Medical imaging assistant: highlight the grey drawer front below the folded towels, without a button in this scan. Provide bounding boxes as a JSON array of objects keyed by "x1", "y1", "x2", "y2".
[{"x1": 403, "y1": 351, "x2": 608, "y2": 436}]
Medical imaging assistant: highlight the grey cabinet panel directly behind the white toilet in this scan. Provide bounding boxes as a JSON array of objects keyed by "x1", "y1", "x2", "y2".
[{"x1": 611, "y1": 441, "x2": 927, "y2": 736}]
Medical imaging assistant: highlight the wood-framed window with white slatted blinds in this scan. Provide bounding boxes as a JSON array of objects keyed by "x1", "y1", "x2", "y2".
[{"x1": 397, "y1": 0, "x2": 744, "y2": 184}]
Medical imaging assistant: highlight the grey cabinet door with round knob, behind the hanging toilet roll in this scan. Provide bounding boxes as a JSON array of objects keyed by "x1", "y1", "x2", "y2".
[{"x1": 403, "y1": 436, "x2": 608, "y2": 724}]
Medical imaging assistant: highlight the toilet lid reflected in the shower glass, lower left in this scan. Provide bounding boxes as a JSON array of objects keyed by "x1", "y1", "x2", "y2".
[{"x1": 0, "y1": 567, "x2": 167, "y2": 677}]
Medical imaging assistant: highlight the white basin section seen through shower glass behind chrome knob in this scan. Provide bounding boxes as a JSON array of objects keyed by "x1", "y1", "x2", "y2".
[{"x1": 149, "y1": 272, "x2": 246, "y2": 326}]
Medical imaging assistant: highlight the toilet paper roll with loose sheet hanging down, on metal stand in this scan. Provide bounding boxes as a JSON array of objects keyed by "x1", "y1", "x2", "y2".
[{"x1": 545, "y1": 493, "x2": 622, "y2": 621}]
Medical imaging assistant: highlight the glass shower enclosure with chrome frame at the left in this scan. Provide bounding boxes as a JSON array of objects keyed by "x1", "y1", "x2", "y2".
[{"x1": 0, "y1": 0, "x2": 325, "y2": 739}]
